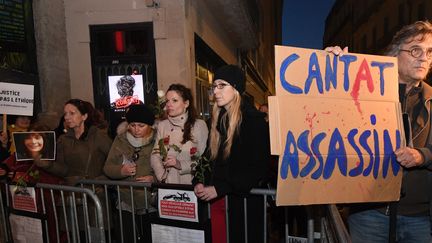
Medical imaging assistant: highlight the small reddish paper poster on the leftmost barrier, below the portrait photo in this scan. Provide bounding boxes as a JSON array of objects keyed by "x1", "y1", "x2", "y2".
[{"x1": 9, "y1": 185, "x2": 37, "y2": 213}]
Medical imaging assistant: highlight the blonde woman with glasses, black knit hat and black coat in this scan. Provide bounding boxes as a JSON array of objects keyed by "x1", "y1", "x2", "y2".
[{"x1": 194, "y1": 65, "x2": 270, "y2": 242}]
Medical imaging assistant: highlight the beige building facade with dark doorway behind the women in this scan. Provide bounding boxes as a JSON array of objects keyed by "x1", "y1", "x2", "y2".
[{"x1": 0, "y1": 0, "x2": 282, "y2": 127}]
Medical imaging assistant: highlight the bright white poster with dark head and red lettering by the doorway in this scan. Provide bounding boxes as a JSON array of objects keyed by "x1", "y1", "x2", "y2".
[{"x1": 108, "y1": 75, "x2": 144, "y2": 111}]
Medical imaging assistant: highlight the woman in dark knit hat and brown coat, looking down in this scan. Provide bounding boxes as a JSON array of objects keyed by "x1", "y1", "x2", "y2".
[{"x1": 103, "y1": 105, "x2": 156, "y2": 242}]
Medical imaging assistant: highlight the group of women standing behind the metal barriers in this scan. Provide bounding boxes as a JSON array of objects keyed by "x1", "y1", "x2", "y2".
[{"x1": 0, "y1": 70, "x2": 270, "y2": 242}]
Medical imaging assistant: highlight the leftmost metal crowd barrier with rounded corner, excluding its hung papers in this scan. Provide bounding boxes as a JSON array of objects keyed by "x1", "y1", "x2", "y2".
[{"x1": 0, "y1": 183, "x2": 105, "y2": 243}]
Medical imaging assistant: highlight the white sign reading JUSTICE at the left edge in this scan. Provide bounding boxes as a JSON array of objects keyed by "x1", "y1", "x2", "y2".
[{"x1": 0, "y1": 82, "x2": 34, "y2": 116}]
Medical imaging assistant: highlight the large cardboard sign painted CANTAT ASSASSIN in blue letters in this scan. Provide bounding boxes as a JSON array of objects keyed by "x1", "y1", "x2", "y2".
[{"x1": 269, "y1": 46, "x2": 405, "y2": 205}]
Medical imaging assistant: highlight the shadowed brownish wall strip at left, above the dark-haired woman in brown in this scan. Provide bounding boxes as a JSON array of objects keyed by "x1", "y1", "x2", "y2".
[{"x1": 33, "y1": 0, "x2": 71, "y2": 128}]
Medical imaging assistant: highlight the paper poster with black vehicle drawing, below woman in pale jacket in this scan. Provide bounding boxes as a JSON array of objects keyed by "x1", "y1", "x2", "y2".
[{"x1": 158, "y1": 188, "x2": 198, "y2": 222}]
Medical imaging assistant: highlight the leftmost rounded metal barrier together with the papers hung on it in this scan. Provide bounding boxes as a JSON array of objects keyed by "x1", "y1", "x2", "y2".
[{"x1": 0, "y1": 183, "x2": 105, "y2": 243}]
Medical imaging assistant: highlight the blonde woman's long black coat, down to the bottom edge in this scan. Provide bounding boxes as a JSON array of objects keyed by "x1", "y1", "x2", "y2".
[{"x1": 210, "y1": 103, "x2": 270, "y2": 242}]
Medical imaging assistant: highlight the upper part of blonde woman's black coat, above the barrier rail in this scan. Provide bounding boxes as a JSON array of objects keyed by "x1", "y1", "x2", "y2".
[{"x1": 210, "y1": 100, "x2": 270, "y2": 196}]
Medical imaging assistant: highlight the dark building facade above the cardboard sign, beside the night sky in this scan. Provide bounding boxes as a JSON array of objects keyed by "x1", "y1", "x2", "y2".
[{"x1": 323, "y1": 0, "x2": 432, "y2": 54}]
